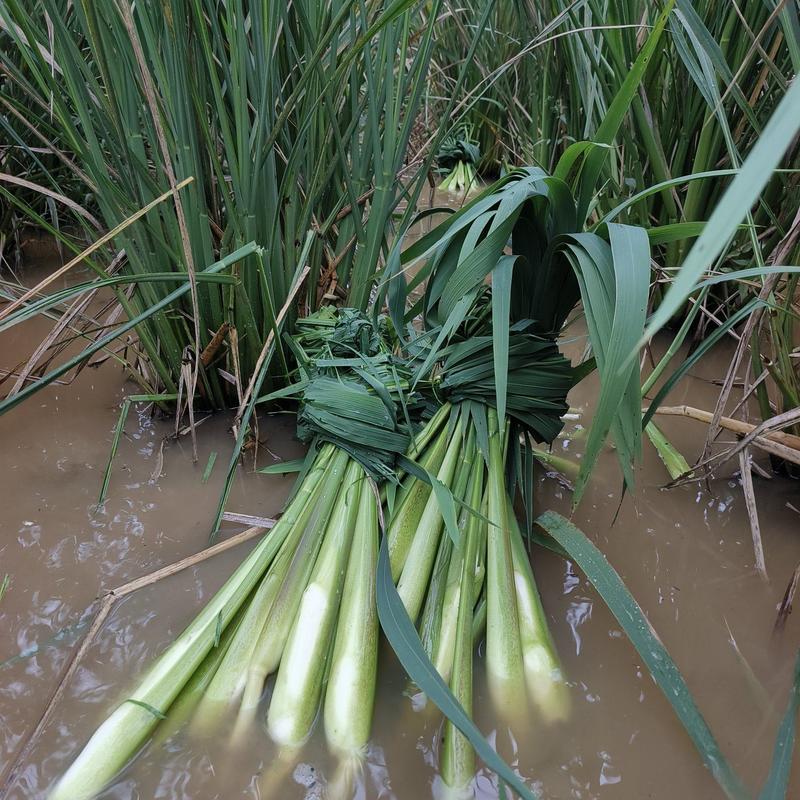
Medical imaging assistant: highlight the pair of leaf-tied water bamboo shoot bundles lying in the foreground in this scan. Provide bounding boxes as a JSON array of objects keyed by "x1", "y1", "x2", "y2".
[{"x1": 52, "y1": 162, "x2": 649, "y2": 800}]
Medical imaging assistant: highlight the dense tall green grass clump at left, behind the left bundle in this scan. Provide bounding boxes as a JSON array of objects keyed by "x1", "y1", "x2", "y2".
[{"x1": 0, "y1": 0, "x2": 446, "y2": 407}]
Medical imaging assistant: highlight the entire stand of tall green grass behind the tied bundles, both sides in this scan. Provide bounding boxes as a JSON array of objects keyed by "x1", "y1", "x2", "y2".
[{"x1": 0, "y1": 0, "x2": 800, "y2": 444}]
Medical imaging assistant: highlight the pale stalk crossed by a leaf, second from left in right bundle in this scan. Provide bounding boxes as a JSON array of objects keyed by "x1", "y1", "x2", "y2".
[{"x1": 397, "y1": 421, "x2": 462, "y2": 621}]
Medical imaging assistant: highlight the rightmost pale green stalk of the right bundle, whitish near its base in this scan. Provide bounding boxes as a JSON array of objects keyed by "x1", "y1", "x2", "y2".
[{"x1": 508, "y1": 499, "x2": 571, "y2": 722}]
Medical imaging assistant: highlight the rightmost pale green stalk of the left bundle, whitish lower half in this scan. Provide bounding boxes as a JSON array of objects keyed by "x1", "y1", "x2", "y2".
[{"x1": 324, "y1": 478, "x2": 378, "y2": 798}]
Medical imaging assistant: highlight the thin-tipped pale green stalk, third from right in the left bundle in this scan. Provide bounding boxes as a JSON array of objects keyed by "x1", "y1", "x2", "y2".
[{"x1": 234, "y1": 450, "x2": 350, "y2": 739}]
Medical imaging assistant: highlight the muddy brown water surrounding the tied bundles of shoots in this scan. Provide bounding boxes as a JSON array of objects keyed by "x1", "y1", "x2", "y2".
[{"x1": 0, "y1": 239, "x2": 800, "y2": 800}]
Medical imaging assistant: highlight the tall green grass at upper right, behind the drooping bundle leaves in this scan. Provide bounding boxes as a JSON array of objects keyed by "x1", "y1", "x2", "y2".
[{"x1": 431, "y1": 0, "x2": 800, "y2": 444}]
